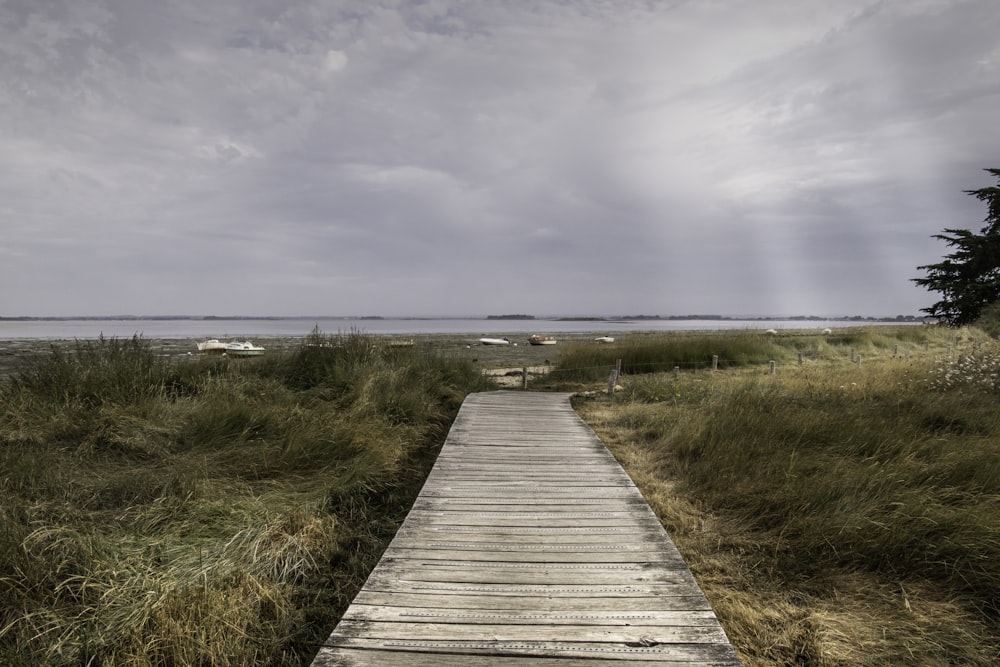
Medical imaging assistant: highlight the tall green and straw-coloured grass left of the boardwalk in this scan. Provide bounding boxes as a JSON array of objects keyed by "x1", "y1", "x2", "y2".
[{"x1": 0, "y1": 332, "x2": 489, "y2": 666}]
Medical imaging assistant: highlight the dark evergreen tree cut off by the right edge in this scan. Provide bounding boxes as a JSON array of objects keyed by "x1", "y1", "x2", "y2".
[{"x1": 913, "y1": 169, "x2": 1000, "y2": 326}]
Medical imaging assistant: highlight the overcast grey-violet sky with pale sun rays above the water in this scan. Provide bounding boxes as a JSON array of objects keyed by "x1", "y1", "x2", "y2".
[{"x1": 0, "y1": 0, "x2": 1000, "y2": 317}]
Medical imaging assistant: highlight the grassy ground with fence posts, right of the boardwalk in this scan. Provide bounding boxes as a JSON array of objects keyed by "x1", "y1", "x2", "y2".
[{"x1": 546, "y1": 326, "x2": 1000, "y2": 667}]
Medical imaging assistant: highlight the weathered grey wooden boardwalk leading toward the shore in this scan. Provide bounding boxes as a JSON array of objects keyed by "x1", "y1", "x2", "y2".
[{"x1": 313, "y1": 391, "x2": 740, "y2": 667}]
